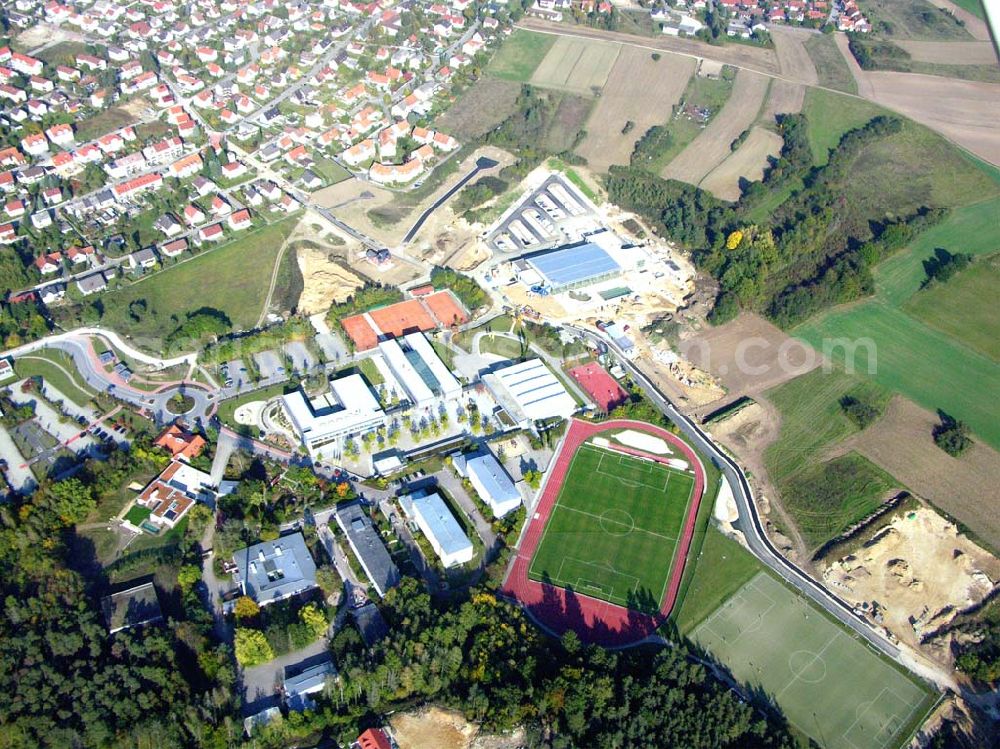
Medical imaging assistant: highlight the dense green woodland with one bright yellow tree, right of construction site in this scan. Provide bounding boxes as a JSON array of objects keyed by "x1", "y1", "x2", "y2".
[{"x1": 607, "y1": 114, "x2": 943, "y2": 327}]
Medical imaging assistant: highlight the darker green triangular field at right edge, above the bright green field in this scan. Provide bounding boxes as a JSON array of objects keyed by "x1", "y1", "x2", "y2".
[{"x1": 903, "y1": 255, "x2": 1000, "y2": 363}]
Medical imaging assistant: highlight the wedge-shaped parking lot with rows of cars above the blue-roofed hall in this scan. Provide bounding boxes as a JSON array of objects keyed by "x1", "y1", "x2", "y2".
[{"x1": 486, "y1": 174, "x2": 596, "y2": 255}]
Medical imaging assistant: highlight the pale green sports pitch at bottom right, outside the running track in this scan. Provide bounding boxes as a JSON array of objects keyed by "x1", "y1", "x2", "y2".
[{"x1": 693, "y1": 572, "x2": 935, "y2": 749}]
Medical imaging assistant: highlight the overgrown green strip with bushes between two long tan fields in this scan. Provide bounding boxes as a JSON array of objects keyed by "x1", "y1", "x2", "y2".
[{"x1": 632, "y1": 66, "x2": 736, "y2": 174}]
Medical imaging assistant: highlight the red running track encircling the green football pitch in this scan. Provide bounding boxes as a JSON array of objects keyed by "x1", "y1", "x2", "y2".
[{"x1": 501, "y1": 419, "x2": 705, "y2": 647}]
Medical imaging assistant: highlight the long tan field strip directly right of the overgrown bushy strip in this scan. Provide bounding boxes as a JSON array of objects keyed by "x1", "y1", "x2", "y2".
[{"x1": 662, "y1": 69, "x2": 769, "y2": 185}]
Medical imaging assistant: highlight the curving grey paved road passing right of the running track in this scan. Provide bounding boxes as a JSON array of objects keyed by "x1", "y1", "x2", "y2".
[{"x1": 568, "y1": 326, "x2": 901, "y2": 661}]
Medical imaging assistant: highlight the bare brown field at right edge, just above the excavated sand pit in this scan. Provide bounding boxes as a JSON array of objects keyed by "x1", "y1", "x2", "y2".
[{"x1": 844, "y1": 396, "x2": 1000, "y2": 549}]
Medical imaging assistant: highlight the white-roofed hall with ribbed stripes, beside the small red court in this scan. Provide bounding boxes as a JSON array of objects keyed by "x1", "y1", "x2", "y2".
[{"x1": 483, "y1": 359, "x2": 576, "y2": 423}]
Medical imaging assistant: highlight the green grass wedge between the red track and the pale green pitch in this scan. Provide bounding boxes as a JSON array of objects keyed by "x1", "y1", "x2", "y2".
[{"x1": 676, "y1": 524, "x2": 764, "y2": 635}]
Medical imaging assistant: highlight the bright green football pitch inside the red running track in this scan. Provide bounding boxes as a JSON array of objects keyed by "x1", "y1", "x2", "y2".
[{"x1": 528, "y1": 444, "x2": 694, "y2": 611}]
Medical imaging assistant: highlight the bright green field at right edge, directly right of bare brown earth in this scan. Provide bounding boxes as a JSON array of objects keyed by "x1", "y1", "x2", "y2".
[{"x1": 794, "y1": 299, "x2": 1000, "y2": 450}]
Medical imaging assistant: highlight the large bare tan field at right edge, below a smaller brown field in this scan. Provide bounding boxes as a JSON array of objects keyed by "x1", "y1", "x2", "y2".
[{"x1": 859, "y1": 72, "x2": 1000, "y2": 166}]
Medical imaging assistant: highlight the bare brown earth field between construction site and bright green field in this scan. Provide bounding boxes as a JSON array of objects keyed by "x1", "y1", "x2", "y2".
[{"x1": 680, "y1": 313, "x2": 820, "y2": 397}]
